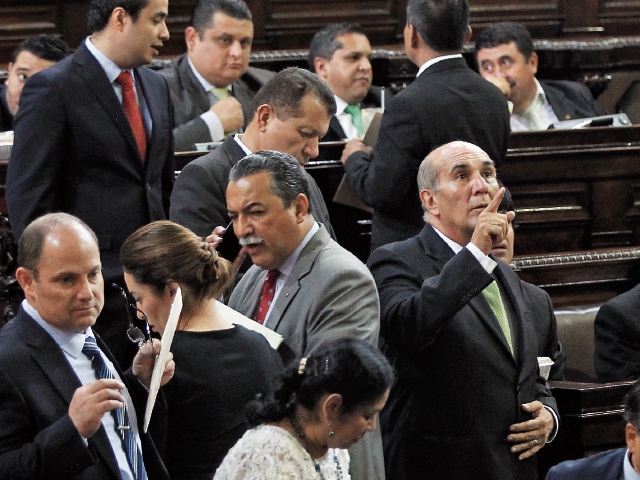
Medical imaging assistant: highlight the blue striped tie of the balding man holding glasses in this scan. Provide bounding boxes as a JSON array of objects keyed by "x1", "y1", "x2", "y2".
[{"x1": 82, "y1": 337, "x2": 147, "y2": 480}]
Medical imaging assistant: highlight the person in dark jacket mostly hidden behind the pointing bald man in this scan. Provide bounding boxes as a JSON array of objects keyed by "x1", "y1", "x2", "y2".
[{"x1": 491, "y1": 186, "x2": 567, "y2": 380}]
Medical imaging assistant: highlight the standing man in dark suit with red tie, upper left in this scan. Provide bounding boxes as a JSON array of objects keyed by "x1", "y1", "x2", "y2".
[{"x1": 6, "y1": 0, "x2": 174, "y2": 366}]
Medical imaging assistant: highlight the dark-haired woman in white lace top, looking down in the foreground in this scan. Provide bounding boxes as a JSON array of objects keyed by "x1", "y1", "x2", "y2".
[{"x1": 215, "y1": 338, "x2": 394, "y2": 480}]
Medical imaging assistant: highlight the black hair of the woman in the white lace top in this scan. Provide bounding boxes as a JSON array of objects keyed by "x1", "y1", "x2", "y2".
[{"x1": 247, "y1": 338, "x2": 395, "y2": 427}]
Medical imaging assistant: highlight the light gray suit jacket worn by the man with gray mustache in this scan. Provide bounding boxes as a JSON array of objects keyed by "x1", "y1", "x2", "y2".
[{"x1": 229, "y1": 226, "x2": 384, "y2": 480}]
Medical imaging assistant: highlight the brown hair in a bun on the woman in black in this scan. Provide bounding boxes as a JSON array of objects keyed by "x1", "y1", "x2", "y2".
[{"x1": 120, "y1": 220, "x2": 232, "y2": 320}]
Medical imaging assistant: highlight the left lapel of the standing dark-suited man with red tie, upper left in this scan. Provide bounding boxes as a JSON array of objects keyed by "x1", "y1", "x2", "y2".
[{"x1": 73, "y1": 42, "x2": 142, "y2": 171}]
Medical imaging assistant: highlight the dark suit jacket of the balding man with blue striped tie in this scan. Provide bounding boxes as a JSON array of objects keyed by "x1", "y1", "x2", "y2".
[{"x1": 0, "y1": 308, "x2": 169, "y2": 480}]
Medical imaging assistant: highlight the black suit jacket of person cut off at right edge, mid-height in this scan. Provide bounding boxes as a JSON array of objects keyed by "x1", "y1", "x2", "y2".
[{"x1": 593, "y1": 285, "x2": 640, "y2": 382}]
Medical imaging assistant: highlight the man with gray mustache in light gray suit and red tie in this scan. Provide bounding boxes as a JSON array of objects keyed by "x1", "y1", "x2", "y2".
[{"x1": 225, "y1": 152, "x2": 384, "y2": 480}]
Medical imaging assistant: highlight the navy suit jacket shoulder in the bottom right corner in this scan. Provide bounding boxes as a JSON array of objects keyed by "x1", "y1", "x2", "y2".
[{"x1": 546, "y1": 448, "x2": 627, "y2": 480}]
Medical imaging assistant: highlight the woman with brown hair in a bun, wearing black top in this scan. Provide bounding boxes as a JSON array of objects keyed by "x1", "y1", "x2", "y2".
[{"x1": 120, "y1": 221, "x2": 282, "y2": 480}]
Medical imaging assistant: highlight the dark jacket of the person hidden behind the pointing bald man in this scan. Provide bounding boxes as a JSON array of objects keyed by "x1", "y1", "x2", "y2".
[{"x1": 520, "y1": 281, "x2": 567, "y2": 380}]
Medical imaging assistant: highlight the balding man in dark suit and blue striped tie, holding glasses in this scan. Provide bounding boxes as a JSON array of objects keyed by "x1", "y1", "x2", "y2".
[{"x1": 0, "y1": 213, "x2": 174, "y2": 480}]
